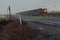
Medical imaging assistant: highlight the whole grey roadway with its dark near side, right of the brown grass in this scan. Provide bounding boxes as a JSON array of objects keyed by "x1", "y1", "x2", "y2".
[{"x1": 11, "y1": 15, "x2": 60, "y2": 40}]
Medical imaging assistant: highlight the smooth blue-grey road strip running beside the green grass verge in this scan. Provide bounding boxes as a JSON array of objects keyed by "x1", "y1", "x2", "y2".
[{"x1": 17, "y1": 15, "x2": 60, "y2": 26}]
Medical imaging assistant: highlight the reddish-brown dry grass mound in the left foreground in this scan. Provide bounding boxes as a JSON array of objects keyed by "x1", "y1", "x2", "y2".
[{"x1": 0, "y1": 21, "x2": 36, "y2": 40}]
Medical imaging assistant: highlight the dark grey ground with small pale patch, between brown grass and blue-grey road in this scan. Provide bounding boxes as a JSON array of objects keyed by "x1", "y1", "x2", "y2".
[{"x1": 26, "y1": 21, "x2": 60, "y2": 40}]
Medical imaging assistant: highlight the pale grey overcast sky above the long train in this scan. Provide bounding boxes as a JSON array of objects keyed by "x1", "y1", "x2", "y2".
[{"x1": 0, "y1": 0, "x2": 60, "y2": 14}]
